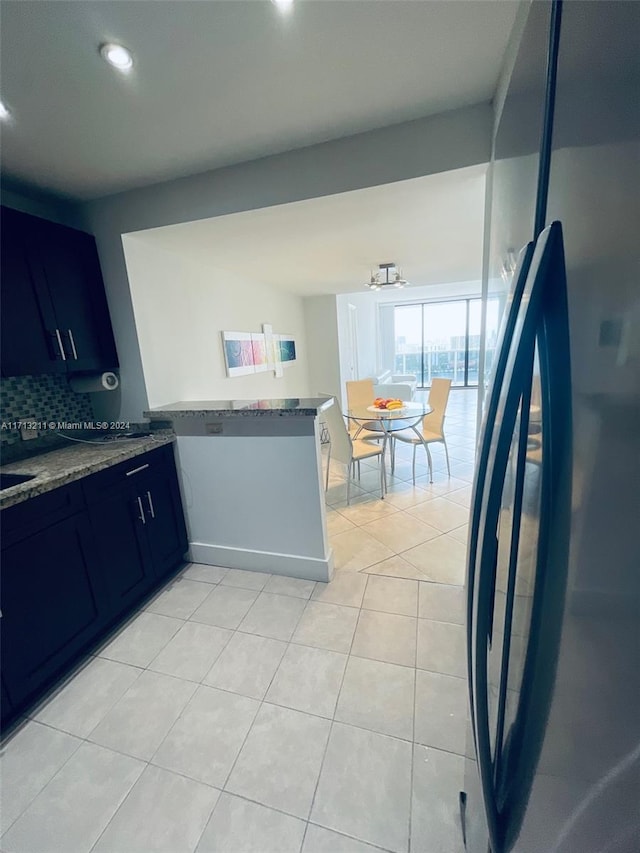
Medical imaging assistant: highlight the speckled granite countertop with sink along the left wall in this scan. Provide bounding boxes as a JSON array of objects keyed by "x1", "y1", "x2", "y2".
[{"x1": 0, "y1": 430, "x2": 175, "y2": 509}]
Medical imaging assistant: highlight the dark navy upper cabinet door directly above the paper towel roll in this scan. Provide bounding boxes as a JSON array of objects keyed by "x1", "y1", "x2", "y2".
[{"x1": 38, "y1": 220, "x2": 118, "y2": 373}]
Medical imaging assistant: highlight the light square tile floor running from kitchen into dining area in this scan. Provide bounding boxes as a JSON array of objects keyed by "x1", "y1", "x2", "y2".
[{"x1": 0, "y1": 391, "x2": 475, "y2": 853}]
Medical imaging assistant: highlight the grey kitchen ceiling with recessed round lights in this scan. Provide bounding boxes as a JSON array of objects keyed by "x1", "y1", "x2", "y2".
[{"x1": 0, "y1": 0, "x2": 518, "y2": 200}]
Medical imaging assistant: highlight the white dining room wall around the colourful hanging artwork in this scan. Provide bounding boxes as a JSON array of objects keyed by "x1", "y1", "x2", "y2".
[{"x1": 123, "y1": 235, "x2": 309, "y2": 407}]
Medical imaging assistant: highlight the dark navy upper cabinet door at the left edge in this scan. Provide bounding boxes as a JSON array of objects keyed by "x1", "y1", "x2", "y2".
[{"x1": 0, "y1": 207, "x2": 66, "y2": 374}]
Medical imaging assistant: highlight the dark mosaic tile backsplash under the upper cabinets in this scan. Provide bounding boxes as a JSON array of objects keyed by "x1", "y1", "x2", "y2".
[{"x1": 0, "y1": 376, "x2": 93, "y2": 447}]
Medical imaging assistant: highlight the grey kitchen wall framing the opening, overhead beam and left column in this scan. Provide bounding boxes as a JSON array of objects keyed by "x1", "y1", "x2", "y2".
[{"x1": 83, "y1": 103, "x2": 493, "y2": 421}]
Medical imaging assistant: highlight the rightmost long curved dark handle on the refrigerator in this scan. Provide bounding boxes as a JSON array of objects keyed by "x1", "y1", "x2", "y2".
[{"x1": 501, "y1": 222, "x2": 572, "y2": 850}]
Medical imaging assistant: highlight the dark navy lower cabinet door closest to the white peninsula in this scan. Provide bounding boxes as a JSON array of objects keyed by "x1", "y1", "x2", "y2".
[{"x1": 137, "y1": 448, "x2": 187, "y2": 576}]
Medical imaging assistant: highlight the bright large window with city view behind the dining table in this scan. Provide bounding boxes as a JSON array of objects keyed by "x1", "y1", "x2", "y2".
[{"x1": 394, "y1": 297, "x2": 499, "y2": 388}]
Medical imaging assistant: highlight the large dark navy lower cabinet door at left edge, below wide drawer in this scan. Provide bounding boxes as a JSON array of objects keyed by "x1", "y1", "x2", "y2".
[{"x1": 0, "y1": 513, "x2": 105, "y2": 706}]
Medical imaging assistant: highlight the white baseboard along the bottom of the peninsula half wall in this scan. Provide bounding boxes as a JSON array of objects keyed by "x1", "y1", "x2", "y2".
[{"x1": 189, "y1": 542, "x2": 333, "y2": 583}]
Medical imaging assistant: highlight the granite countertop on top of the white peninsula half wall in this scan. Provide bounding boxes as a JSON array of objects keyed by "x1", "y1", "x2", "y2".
[{"x1": 144, "y1": 397, "x2": 332, "y2": 420}]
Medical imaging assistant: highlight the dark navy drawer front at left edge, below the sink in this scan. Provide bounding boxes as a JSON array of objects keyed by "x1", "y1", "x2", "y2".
[{"x1": 0, "y1": 482, "x2": 85, "y2": 550}]
